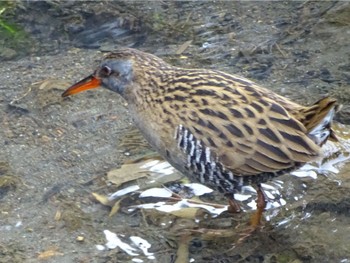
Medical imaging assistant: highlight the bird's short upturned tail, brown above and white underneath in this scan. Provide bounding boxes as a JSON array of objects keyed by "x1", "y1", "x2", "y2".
[{"x1": 301, "y1": 97, "x2": 341, "y2": 146}]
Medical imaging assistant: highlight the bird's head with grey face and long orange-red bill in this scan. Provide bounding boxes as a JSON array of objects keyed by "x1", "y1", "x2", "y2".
[{"x1": 62, "y1": 48, "x2": 173, "y2": 101}]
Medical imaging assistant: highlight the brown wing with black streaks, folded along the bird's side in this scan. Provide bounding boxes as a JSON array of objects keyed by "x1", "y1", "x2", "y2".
[{"x1": 171, "y1": 71, "x2": 320, "y2": 176}]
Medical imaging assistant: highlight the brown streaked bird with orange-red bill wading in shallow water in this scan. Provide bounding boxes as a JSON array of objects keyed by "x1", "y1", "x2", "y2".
[{"x1": 62, "y1": 48, "x2": 340, "y2": 228}]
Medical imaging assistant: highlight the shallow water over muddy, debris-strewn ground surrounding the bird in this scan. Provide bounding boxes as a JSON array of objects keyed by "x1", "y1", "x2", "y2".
[{"x1": 0, "y1": 2, "x2": 350, "y2": 262}]
